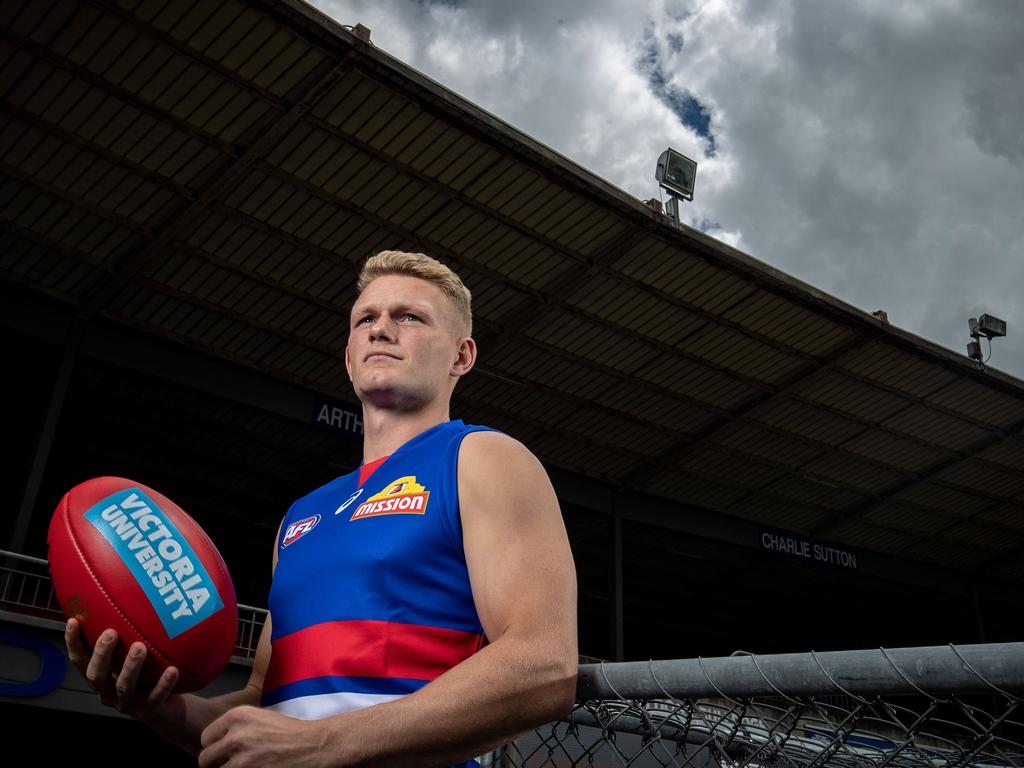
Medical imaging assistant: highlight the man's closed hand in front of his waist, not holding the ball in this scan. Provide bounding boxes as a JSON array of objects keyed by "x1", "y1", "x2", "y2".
[{"x1": 199, "y1": 707, "x2": 327, "y2": 768}]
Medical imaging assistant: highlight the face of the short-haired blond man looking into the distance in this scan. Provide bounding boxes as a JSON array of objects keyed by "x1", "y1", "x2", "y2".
[{"x1": 345, "y1": 274, "x2": 468, "y2": 410}]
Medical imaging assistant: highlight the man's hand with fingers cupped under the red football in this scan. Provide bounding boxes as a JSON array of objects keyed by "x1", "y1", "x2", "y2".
[{"x1": 65, "y1": 618, "x2": 179, "y2": 721}]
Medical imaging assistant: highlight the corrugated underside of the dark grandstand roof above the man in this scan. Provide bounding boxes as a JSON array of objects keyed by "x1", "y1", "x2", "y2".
[{"x1": 0, "y1": 0, "x2": 1024, "y2": 573}]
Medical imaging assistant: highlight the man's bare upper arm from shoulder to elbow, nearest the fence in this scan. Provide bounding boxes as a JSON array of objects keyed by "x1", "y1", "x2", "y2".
[{"x1": 459, "y1": 432, "x2": 577, "y2": 655}]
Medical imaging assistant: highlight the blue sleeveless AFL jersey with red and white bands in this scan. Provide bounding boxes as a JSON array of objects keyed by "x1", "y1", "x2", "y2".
[{"x1": 262, "y1": 421, "x2": 487, "y2": 757}]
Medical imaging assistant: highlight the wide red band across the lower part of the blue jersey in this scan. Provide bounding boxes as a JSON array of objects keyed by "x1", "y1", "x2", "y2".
[{"x1": 263, "y1": 621, "x2": 483, "y2": 690}]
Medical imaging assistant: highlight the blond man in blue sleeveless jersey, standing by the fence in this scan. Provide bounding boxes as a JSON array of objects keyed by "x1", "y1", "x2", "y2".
[{"x1": 67, "y1": 251, "x2": 577, "y2": 766}]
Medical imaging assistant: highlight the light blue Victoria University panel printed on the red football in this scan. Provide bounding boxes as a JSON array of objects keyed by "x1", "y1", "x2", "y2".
[{"x1": 85, "y1": 487, "x2": 224, "y2": 638}]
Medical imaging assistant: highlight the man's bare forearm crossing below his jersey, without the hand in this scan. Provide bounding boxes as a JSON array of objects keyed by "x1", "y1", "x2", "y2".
[{"x1": 324, "y1": 637, "x2": 577, "y2": 766}]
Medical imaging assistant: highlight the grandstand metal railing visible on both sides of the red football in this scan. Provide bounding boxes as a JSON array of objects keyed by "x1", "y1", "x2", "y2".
[{"x1": 0, "y1": 550, "x2": 267, "y2": 659}]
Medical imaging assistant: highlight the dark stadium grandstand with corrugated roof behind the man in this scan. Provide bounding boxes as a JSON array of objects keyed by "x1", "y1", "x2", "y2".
[{"x1": 0, "y1": 0, "x2": 1024, "y2": 764}]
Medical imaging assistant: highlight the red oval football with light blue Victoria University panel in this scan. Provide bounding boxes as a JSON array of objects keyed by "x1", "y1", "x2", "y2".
[{"x1": 47, "y1": 477, "x2": 239, "y2": 691}]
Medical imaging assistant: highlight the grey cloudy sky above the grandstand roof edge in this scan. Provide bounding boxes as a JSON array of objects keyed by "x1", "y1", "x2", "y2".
[{"x1": 314, "y1": 0, "x2": 1024, "y2": 378}]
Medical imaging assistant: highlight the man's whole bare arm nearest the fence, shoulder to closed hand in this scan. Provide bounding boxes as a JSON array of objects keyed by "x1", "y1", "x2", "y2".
[{"x1": 200, "y1": 432, "x2": 578, "y2": 766}]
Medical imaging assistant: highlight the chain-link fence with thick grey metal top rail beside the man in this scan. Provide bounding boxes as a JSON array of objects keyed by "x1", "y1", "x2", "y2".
[{"x1": 505, "y1": 643, "x2": 1024, "y2": 768}]
